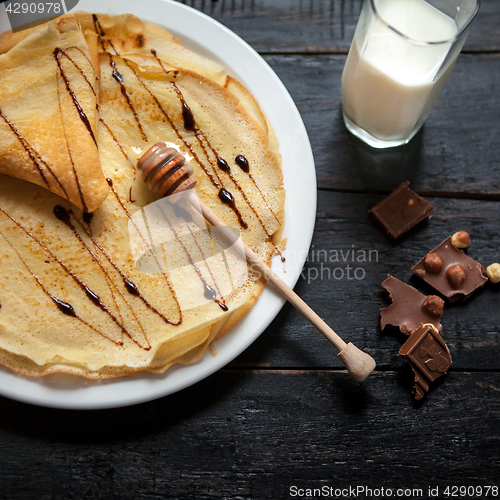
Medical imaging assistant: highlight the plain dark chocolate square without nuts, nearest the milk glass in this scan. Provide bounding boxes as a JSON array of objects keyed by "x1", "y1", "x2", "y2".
[{"x1": 368, "y1": 181, "x2": 434, "y2": 239}]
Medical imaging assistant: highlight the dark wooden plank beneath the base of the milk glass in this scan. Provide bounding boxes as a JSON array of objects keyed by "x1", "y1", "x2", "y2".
[{"x1": 266, "y1": 53, "x2": 500, "y2": 194}]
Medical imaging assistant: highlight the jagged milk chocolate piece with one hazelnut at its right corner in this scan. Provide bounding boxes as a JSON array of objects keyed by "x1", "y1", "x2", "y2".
[{"x1": 380, "y1": 275, "x2": 444, "y2": 335}]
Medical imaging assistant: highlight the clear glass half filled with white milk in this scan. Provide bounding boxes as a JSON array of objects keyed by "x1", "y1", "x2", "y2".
[{"x1": 342, "y1": 0, "x2": 479, "y2": 148}]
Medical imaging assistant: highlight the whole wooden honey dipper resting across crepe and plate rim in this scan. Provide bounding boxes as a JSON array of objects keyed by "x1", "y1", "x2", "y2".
[{"x1": 137, "y1": 142, "x2": 375, "y2": 381}]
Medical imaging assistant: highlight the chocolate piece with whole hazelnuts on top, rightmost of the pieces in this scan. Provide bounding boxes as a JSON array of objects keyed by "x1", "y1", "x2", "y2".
[{"x1": 412, "y1": 236, "x2": 488, "y2": 302}]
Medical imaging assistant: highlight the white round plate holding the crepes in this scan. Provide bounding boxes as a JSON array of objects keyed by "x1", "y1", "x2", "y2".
[{"x1": 0, "y1": 0, "x2": 316, "y2": 409}]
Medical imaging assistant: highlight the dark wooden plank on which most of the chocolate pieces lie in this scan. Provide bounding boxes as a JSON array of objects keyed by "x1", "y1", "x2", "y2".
[{"x1": 232, "y1": 191, "x2": 500, "y2": 370}]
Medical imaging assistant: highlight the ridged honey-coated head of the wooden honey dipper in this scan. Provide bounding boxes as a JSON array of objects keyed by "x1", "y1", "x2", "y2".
[{"x1": 137, "y1": 142, "x2": 196, "y2": 197}]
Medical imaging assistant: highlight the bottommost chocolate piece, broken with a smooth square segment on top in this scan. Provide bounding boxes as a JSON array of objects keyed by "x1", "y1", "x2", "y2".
[{"x1": 399, "y1": 325, "x2": 451, "y2": 400}]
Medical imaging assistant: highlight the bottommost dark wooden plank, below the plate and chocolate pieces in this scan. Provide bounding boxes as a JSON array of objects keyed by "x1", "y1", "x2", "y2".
[{"x1": 0, "y1": 370, "x2": 500, "y2": 500}]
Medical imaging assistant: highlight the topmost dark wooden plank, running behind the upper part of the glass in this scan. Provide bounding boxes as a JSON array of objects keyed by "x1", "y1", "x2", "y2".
[{"x1": 175, "y1": 0, "x2": 500, "y2": 53}]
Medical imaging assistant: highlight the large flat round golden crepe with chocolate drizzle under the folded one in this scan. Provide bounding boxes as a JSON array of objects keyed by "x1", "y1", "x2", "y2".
[{"x1": 0, "y1": 14, "x2": 284, "y2": 378}]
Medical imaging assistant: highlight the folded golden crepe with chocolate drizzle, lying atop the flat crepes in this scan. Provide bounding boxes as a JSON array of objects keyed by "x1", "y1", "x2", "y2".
[{"x1": 0, "y1": 17, "x2": 108, "y2": 212}]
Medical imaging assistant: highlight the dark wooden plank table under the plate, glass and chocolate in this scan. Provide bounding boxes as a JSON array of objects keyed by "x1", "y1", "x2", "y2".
[{"x1": 0, "y1": 0, "x2": 500, "y2": 500}]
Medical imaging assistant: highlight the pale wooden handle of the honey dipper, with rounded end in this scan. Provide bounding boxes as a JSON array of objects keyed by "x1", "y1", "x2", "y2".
[{"x1": 185, "y1": 190, "x2": 375, "y2": 381}]
